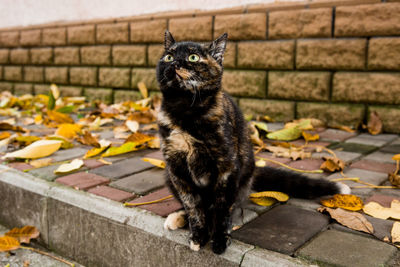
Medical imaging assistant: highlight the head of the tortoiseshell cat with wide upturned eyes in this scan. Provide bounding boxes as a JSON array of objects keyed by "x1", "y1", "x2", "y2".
[{"x1": 157, "y1": 31, "x2": 228, "y2": 94}]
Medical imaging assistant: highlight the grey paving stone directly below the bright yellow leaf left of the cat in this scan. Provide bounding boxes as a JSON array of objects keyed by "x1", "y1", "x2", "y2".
[{"x1": 90, "y1": 157, "x2": 153, "y2": 179}]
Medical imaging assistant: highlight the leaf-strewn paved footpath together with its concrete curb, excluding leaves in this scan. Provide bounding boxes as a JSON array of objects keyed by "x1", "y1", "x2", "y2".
[{"x1": 0, "y1": 114, "x2": 400, "y2": 267}]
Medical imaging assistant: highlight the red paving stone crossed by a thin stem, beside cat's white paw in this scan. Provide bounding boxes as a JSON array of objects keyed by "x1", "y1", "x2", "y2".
[{"x1": 129, "y1": 187, "x2": 182, "y2": 217}]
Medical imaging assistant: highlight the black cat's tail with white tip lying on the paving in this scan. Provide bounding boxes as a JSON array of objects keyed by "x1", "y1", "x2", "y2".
[{"x1": 252, "y1": 167, "x2": 351, "y2": 199}]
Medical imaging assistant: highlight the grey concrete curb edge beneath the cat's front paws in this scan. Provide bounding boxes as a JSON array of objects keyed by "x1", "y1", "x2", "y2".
[{"x1": 0, "y1": 165, "x2": 307, "y2": 266}]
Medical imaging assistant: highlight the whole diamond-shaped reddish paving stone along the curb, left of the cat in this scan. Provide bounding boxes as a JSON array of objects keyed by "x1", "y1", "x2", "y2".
[{"x1": 56, "y1": 172, "x2": 110, "y2": 190}]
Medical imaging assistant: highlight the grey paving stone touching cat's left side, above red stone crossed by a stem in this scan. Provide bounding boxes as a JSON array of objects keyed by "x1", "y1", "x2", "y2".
[{"x1": 110, "y1": 168, "x2": 165, "y2": 195}]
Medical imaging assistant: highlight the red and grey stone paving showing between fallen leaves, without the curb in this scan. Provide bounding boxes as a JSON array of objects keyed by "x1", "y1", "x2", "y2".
[{"x1": 3, "y1": 118, "x2": 400, "y2": 266}]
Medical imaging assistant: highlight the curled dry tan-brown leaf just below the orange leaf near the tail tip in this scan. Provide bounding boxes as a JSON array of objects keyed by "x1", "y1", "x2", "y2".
[{"x1": 318, "y1": 207, "x2": 374, "y2": 234}]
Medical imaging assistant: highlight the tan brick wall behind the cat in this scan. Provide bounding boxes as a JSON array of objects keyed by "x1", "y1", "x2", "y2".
[{"x1": 0, "y1": 0, "x2": 400, "y2": 133}]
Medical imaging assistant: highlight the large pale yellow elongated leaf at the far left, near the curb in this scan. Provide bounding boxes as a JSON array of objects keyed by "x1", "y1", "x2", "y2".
[{"x1": 3, "y1": 140, "x2": 62, "y2": 159}]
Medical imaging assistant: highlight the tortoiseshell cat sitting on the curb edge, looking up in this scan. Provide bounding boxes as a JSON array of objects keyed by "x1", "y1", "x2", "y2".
[{"x1": 157, "y1": 31, "x2": 350, "y2": 254}]
